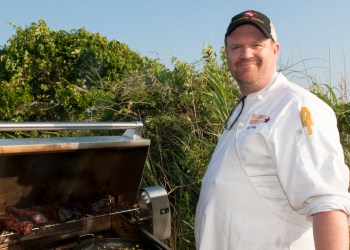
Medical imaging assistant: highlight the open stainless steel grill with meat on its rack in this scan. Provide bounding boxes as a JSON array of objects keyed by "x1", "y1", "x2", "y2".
[{"x1": 0, "y1": 122, "x2": 171, "y2": 249}]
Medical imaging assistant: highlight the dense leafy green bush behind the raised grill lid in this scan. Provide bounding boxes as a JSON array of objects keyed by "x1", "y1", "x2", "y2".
[{"x1": 0, "y1": 20, "x2": 144, "y2": 121}]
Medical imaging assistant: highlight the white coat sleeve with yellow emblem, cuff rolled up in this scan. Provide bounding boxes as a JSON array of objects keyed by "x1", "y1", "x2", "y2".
[{"x1": 271, "y1": 93, "x2": 350, "y2": 216}]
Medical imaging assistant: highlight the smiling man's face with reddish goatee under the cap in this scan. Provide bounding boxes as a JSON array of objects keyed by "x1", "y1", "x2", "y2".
[{"x1": 226, "y1": 24, "x2": 279, "y2": 95}]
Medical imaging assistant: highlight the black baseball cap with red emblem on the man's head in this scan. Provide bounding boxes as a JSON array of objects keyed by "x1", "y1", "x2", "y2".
[{"x1": 225, "y1": 10, "x2": 277, "y2": 42}]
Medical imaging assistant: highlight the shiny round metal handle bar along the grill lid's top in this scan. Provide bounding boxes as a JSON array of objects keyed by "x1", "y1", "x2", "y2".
[{"x1": 0, "y1": 121, "x2": 143, "y2": 131}]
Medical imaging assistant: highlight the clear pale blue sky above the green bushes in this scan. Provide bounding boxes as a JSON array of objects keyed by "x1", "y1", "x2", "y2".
[{"x1": 0, "y1": 0, "x2": 350, "y2": 94}]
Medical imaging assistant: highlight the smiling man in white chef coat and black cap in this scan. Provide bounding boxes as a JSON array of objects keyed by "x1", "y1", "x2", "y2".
[{"x1": 195, "y1": 11, "x2": 350, "y2": 250}]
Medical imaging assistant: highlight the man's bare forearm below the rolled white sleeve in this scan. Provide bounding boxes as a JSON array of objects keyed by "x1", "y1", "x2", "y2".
[{"x1": 313, "y1": 211, "x2": 349, "y2": 250}]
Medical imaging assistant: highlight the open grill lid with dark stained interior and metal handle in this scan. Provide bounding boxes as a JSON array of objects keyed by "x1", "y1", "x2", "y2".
[{"x1": 0, "y1": 122, "x2": 150, "y2": 212}]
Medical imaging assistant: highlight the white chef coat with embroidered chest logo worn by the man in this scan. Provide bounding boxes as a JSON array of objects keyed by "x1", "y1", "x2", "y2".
[{"x1": 195, "y1": 73, "x2": 350, "y2": 250}]
